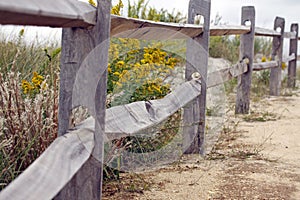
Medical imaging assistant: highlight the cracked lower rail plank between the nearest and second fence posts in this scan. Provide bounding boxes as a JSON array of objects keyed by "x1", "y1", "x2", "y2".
[{"x1": 75, "y1": 79, "x2": 201, "y2": 140}]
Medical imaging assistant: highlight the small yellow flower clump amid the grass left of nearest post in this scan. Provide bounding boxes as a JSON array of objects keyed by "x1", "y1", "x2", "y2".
[{"x1": 22, "y1": 72, "x2": 46, "y2": 95}]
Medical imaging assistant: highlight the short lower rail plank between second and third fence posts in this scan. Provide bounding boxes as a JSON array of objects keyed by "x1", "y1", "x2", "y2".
[{"x1": 207, "y1": 62, "x2": 248, "y2": 88}]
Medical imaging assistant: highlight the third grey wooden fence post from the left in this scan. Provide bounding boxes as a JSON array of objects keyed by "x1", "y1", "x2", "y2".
[{"x1": 235, "y1": 6, "x2": 255, "y2": 114}]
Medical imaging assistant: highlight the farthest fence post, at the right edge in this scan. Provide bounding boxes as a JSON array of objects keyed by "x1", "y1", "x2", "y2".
[{"x1": 288, "y1": 24, "x2": 299, "y2": 88}]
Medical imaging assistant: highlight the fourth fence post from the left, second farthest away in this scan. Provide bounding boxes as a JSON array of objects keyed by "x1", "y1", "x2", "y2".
[{"x1": 270, "y1": 17, "x2": 285, "y2": 96}]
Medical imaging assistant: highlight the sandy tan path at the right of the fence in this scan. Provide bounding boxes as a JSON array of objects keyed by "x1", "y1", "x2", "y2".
[{"x1": 103, "y1": 87, "x2": 300, "y2": 200}]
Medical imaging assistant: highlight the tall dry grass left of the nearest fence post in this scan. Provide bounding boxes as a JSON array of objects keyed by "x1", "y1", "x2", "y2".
[{"x1": 0, "y1": 29, "x2": 60, "y2": 189}]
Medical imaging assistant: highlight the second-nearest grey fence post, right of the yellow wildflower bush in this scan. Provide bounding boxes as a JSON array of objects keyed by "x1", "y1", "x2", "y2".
[{"x1": 183, "y1": 0, "x2": 211, "y2": 155}]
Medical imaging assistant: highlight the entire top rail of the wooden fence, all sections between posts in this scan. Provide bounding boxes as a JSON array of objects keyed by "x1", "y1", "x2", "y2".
[{"x1": 0, "y1": 0, "x2": 300, "y2": 40}]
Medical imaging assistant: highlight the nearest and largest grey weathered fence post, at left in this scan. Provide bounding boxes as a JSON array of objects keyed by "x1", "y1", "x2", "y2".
[{"x1": 55, "y1": 0, "x2": 111, "y2": 200}]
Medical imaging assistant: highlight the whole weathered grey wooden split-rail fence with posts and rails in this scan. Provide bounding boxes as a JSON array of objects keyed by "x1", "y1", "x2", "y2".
[{"x1": 0, "y1": 0, "x2": 300, "y2": 200}]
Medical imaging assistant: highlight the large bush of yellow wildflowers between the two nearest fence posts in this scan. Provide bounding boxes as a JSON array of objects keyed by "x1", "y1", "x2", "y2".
[{"x1": 108, "y1": 38, "x2": 179, "y2": 105}]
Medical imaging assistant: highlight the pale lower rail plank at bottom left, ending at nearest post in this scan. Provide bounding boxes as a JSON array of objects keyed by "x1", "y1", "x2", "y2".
[{"x1": 0, "y1": 129, "x2": 94, "y2": 200}]
